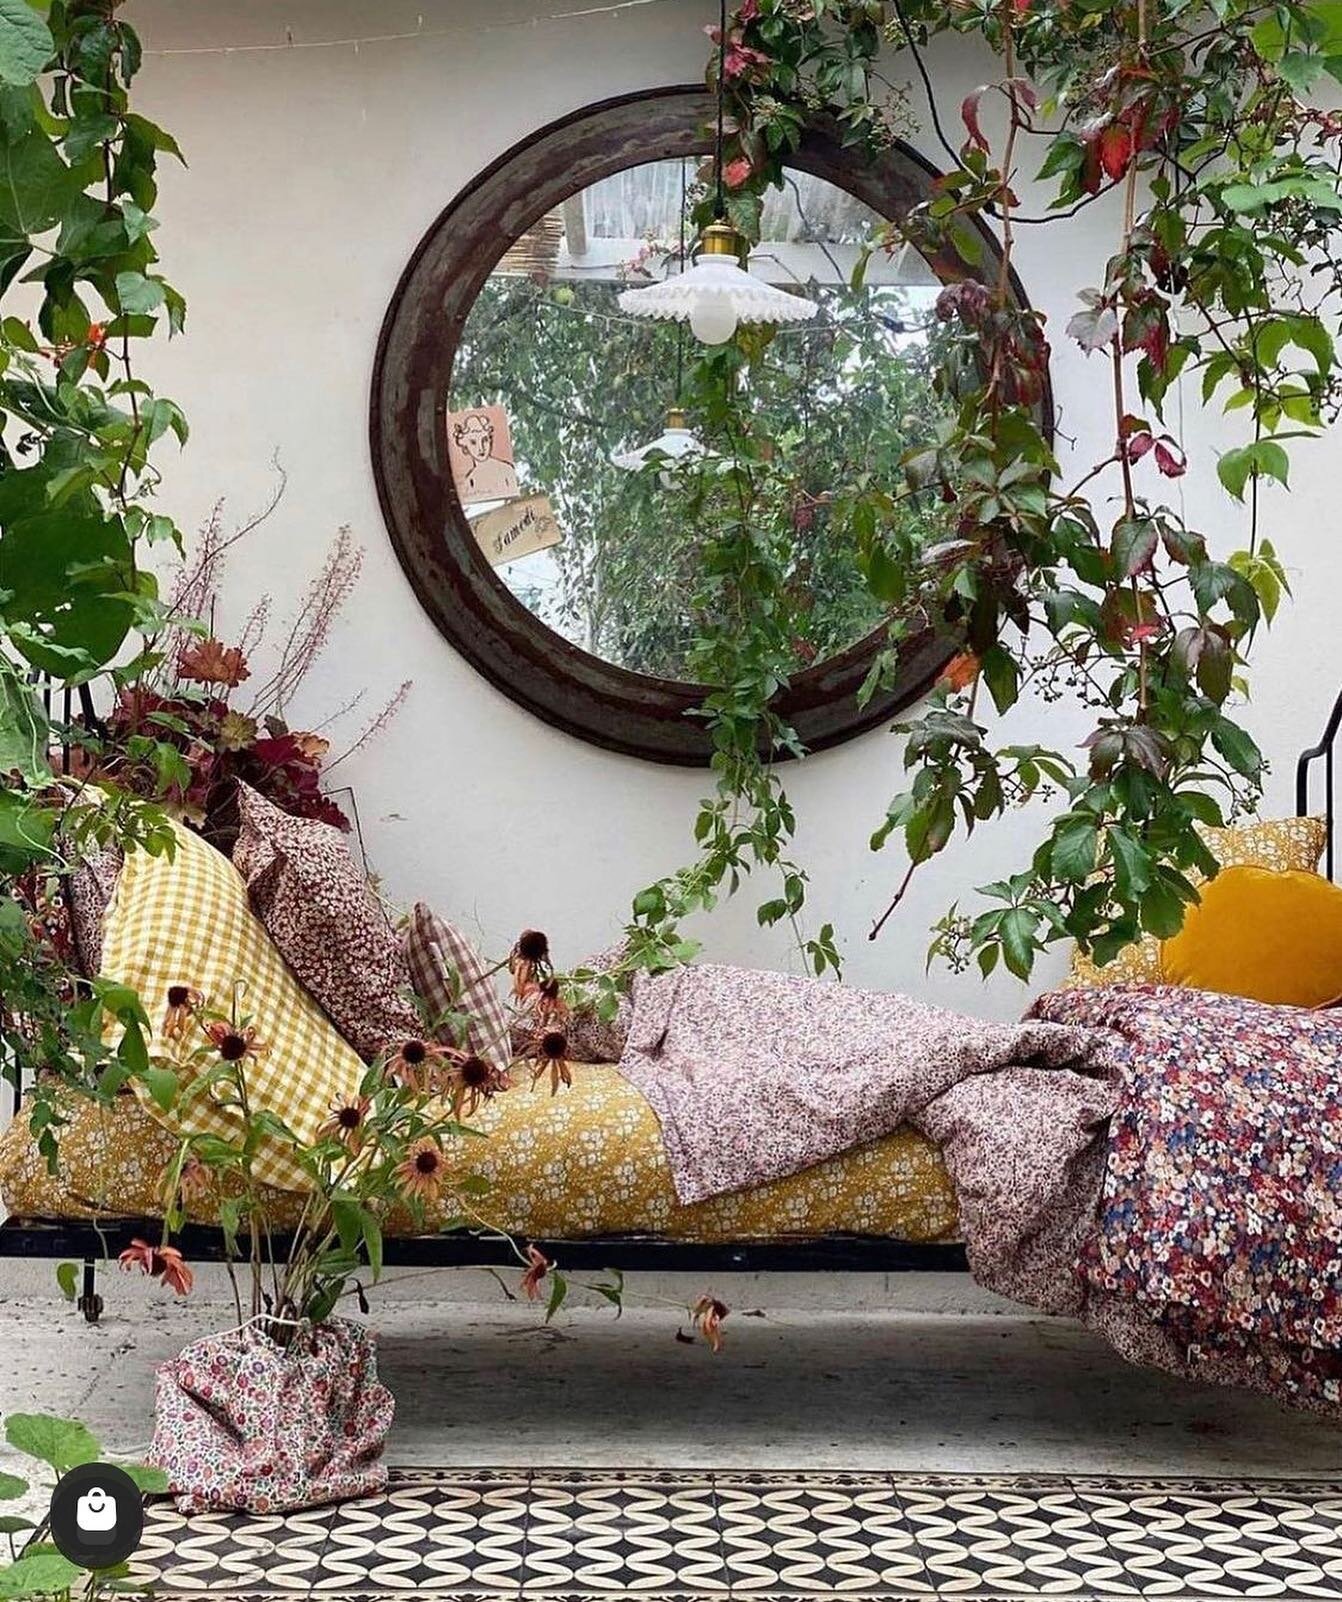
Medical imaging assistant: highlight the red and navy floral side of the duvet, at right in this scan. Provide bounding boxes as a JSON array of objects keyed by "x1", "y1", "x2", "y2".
[{"x1": 1033, "y1": 985, "x2": 1342, "y2": 1411}]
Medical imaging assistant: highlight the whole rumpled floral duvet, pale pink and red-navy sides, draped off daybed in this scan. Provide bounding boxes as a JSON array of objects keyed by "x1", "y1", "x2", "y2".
[{"x1": 620, "y1": 964, "x2": 1342, "y2": 1416}]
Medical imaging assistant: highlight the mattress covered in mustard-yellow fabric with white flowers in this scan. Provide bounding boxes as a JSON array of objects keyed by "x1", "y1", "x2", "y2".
[{"x1": 0, "y1": 1064, "x2": 956, "y2": 1243}]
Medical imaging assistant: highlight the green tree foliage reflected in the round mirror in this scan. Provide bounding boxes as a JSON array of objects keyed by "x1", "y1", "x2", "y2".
[{"x1": 452, "y1": 272, "x2": 946, "y2": 679}]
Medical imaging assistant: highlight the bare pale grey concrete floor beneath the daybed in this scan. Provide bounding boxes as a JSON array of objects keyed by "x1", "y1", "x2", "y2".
[{"x1": 0, "y1": 1262, "x2": 1342, "y2": 1499}]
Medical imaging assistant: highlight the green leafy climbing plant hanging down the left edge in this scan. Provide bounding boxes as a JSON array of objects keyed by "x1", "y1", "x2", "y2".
[{"x1": 0, "y1": 0, "x2": 187, "y2": 1121}]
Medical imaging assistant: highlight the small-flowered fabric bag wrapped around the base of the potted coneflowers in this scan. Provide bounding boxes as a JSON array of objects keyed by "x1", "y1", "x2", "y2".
[{"x1": 149, "y1": 1318, "x2": 396, "y2": 1512}]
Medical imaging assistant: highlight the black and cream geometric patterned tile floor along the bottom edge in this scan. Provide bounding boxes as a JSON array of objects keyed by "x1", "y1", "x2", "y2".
[{"x1": 135, "y1": 1469, "x2": 1342, "y2": 1602}]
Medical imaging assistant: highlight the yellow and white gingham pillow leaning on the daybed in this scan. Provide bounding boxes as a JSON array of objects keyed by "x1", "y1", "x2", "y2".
[{"x1": 102, "y1": 823, "x2": 364, "y2": 1190}]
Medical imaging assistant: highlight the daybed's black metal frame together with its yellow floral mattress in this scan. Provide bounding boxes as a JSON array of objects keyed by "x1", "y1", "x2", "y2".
[{"x1": 0, "y1": 697, "x2": 1342, "y2": 1339}]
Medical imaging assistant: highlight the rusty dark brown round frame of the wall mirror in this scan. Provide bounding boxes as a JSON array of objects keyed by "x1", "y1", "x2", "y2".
[{"x1": 370, "y1": 87, "x2": 1052, "y2": 766}]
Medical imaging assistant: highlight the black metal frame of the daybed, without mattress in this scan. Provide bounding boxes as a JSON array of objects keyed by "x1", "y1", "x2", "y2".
[{"x1": 0, "y1": 692, "x2": 1342, "y2": 1323}]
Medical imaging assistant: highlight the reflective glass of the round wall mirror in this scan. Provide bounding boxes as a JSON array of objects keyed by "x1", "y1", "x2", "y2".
[{"x1": 447, "y1": 160, "x2": 946, "y2": 681}]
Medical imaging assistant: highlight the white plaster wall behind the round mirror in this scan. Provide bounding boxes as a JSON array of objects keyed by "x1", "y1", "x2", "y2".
[{"x1": 120, "y1": 0, "x2": 1342, "y2": 1016}]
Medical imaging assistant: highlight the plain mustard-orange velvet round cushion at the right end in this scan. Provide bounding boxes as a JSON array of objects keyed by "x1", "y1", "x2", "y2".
[{"x1": 1161, "y1": 867, "x2": 1342, "y2": 1008}]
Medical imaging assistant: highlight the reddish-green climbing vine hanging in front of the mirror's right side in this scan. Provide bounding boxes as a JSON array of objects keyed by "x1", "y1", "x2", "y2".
[{"x1": 634, "y1": 0, "x2": 1342, "y2": 979}]
